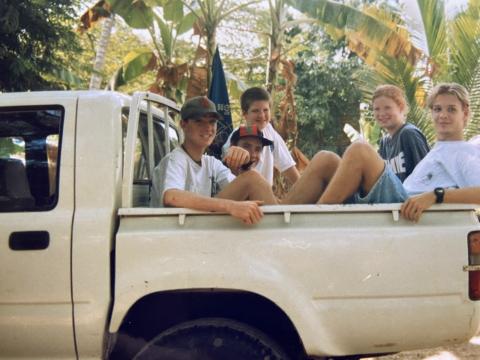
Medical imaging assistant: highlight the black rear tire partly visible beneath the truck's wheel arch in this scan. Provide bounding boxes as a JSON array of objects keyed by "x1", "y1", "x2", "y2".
[{"x1": 134, "y1": 318, "x2": 289, "y2": 360}]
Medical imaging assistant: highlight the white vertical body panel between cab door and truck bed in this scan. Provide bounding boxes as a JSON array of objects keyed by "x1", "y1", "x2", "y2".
[{"x1": 72, "y1": 92, "x2": 130, "y2": 358}]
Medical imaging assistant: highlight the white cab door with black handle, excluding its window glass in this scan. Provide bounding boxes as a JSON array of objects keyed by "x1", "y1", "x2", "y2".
[{"x1": 0, "y1": 93, "x2": 77, "y2": 359}]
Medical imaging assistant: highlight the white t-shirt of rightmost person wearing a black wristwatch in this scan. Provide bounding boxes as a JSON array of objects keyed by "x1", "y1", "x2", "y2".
[{"x1": 403, "y1": 141, "x2": 480, "y2": 194}]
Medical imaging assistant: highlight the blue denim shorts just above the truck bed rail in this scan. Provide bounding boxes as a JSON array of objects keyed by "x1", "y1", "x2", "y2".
[{"x1": 350, "y1": 164, "x2": 408, "y2": 204}]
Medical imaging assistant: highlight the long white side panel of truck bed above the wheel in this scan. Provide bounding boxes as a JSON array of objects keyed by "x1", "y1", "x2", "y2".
[{"x1": 110, "y1": 204, "x2": 480, "y2": 355}]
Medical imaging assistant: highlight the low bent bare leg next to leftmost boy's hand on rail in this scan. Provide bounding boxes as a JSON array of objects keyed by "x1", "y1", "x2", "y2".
[{"x1": 217, "y1": 170, "x2": 277, "y2": 205}]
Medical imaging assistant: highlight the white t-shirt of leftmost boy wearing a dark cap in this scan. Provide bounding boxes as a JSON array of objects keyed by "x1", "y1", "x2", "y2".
[{"x1": 150, "y1": 147, "x2": 235, "y2": 207}]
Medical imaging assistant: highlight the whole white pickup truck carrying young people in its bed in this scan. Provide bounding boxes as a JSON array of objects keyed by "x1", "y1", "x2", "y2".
[{"x1": 0, "y1": 91, "x2": 480, "y2": 359}]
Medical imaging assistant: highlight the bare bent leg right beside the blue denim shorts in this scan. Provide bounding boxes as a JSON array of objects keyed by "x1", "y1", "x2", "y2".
[{"x1": 318, "y1": 142, "x2": 385, "y2": 204}]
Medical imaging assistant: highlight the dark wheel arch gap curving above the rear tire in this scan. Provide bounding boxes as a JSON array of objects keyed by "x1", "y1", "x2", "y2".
[{"x1": 111, "y1": 289, "x2": 305, "y2": 359}]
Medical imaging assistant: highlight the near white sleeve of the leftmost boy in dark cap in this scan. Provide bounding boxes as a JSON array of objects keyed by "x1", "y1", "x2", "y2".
[{"x1": 150, "y1": 154, "x2": 188, "y2": 207}]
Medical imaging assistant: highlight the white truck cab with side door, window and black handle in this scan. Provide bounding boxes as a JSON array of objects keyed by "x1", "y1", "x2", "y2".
[{"x1": 0, "y1": 91, "x2": 180, "y2": 358}]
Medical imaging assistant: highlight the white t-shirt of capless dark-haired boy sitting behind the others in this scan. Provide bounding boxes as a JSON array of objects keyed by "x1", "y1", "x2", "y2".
[{"x1": 222, "y1": 124, "x2": 295, "y2": 185}]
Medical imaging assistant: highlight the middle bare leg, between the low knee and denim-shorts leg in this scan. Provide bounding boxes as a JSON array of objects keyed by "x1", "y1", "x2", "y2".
[{"x1": 281, "y1": 151, "x2": 341, "y2": 204}]
